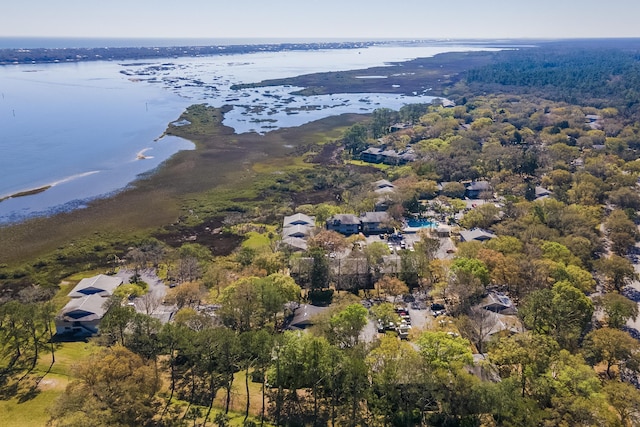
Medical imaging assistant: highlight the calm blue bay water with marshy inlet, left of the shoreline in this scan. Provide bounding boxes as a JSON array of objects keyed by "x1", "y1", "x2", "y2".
[{"x1": 0, "y1": 41, "x2": 500, "y2": 224}]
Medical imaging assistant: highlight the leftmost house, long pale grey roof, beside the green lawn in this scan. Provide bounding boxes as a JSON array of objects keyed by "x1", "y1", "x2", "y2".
[{"x1": 55, "y1": 274, "x2": 122, "y2": 336}]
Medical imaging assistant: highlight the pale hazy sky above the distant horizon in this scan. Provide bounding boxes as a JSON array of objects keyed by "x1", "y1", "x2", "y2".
[{"x1": 0, "y1": 0, "x2": 640, "y2": 39}]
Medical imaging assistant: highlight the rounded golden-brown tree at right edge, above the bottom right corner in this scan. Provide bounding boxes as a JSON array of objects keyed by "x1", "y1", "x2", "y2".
[{"x1": 583, "y1": 328, "x2": 640, "y2": 379}]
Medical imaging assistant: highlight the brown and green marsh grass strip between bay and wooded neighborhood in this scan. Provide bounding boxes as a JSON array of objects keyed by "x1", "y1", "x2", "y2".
[{"x1": 0, "y1": 106, "x2": 363, "y2": 289}]
